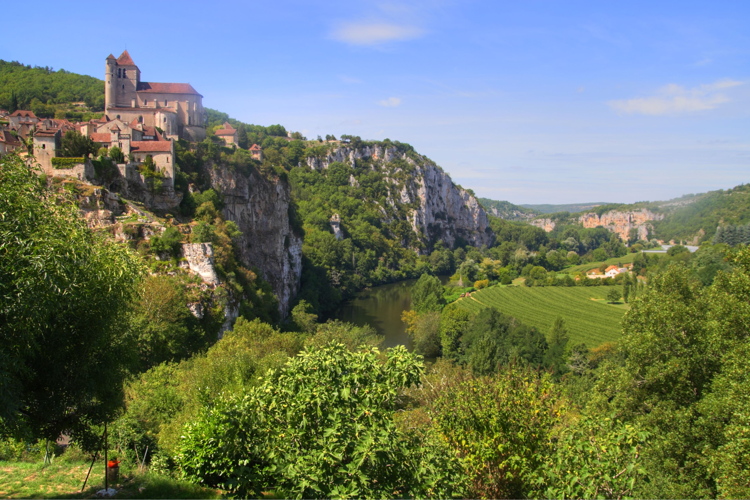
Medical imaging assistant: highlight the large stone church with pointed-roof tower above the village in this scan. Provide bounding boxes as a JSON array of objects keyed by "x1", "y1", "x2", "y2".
[{"x1": 104, "y1": 50, "x2": 207, "y2": 142}]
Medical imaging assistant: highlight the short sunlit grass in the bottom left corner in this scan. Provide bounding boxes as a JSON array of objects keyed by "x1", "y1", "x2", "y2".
[{"x1": 0, "y1": 459, "x2": 220, "y2": 498}]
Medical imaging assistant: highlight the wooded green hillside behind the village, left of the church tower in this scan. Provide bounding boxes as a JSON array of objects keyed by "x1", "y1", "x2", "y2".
[{"x1": 0, "y1": 60, "x2": 104, "y2": 117}]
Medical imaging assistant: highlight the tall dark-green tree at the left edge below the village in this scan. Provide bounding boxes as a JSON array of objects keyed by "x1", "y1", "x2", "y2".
[{"x1": 0, "y1": 155, "x2": 140, "y2": 439}]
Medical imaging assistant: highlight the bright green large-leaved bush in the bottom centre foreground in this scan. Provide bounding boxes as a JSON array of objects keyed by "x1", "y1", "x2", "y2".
[{"x1": 177, "y1": 344, "x2": 462, "y2": 498}]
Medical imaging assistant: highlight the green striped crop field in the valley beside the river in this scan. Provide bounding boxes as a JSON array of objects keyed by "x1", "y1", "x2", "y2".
[{"x1": 455, "y1": 286, "x2": 628, "y2": 347}]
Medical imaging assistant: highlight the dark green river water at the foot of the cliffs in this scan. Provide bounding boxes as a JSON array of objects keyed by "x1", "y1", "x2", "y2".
[{"x1": 333, "y1": 276, "x2": 448, "y2": 350}]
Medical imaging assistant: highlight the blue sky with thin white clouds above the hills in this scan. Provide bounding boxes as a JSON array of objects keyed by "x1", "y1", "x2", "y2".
[{"x1": 0, "y1": 0, "x2": 750, "y2": 203}]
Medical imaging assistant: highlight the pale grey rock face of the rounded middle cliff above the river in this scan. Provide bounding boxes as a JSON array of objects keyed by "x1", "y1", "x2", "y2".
[{"x1": 307, "y1": 145, "x2": 494, "y2": 251}]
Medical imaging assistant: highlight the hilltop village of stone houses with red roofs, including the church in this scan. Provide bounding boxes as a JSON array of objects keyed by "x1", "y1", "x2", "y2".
[{"x1": 0, "y1": 50, "x2": 263, "y2": 189}]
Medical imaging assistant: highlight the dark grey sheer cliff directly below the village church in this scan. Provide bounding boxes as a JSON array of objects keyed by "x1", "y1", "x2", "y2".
[{"x1": 207, "y1": 165, "x2": 302, "y2": 317}]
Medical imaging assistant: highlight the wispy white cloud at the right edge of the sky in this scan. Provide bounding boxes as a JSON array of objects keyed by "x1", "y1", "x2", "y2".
[{"x1": 608, "y1": 80, "x2": 744, "y2": 116}]
